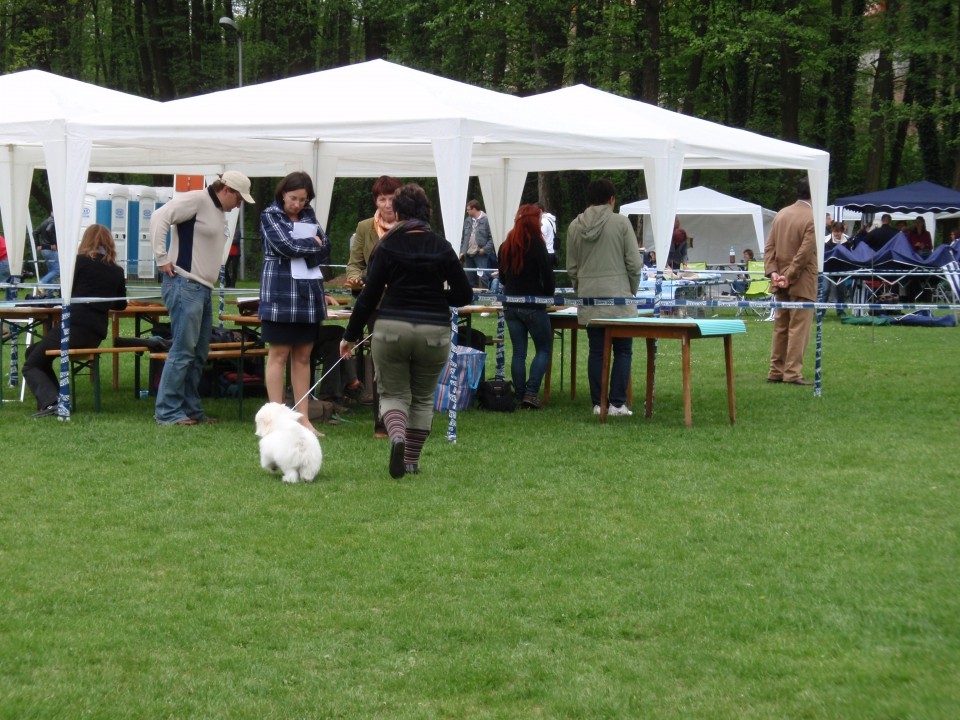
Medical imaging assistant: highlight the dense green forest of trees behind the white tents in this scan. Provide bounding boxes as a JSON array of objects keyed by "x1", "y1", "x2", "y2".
[{"x1": 0, "y1": 0, "x2": 960, "y2": 276}]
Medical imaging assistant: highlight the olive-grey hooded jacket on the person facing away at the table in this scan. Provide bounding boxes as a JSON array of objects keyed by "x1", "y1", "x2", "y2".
[{"x1": 567, "y1": 203, "x2": 643, "y2": 325}]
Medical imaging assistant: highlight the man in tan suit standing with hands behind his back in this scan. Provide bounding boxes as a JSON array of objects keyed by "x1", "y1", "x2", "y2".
[{"x1": 763, "y1": 178, "x2": 817, "y2": 385}]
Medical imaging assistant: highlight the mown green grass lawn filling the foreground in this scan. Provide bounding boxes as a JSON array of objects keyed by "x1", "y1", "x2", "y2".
[{"x1": 0, "y1": 315, "x2": 960, "y2": 720}]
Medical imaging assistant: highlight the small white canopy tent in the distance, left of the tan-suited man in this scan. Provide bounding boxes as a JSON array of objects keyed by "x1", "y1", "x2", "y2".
[{"x1": 620, "y1": 185, "x2": 776, "y2": 265}]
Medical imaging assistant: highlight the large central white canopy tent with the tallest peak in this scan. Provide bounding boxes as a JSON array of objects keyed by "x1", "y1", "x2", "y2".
[{"x1": 68, "y1": 60, "x2": 670, "y2": 262}]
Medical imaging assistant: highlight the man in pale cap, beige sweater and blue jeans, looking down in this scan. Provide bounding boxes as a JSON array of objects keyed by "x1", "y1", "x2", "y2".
[{"x1": 150, "y1": 170, "x2": 254, "y2": 425}]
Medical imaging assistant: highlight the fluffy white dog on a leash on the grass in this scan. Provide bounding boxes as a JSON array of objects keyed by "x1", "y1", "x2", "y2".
[{"x1": 256, "y1": 403, "x2": 323, "y2": 483}]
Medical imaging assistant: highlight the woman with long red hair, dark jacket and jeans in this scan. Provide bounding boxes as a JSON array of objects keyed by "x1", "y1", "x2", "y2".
[{"x1": 498, "y1": 205, "x2": 556, "y2": 409}]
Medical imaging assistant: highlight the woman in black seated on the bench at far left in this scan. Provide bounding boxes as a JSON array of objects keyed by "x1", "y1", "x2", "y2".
[{"x1": 23, "y1": 225, "x2": 127, "y2": 417}]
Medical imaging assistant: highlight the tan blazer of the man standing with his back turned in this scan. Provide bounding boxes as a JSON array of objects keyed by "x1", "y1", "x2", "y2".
[{"x1": 763, "y1": 200, "x2": 817, "y2": 301}]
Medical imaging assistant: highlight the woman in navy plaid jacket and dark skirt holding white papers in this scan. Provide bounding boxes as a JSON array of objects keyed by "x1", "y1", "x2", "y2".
[{"x1": 258, "y1": 171, "x2": 330, "y2": 435}]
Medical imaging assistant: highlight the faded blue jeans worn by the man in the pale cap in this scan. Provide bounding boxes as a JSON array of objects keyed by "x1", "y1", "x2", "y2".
[{"x1": 155, "y1": 275, "x2": 213, "y2": 425}]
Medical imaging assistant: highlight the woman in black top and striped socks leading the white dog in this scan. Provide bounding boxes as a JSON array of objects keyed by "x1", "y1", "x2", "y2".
[{"x1": 340, "y1": 183, "x2": 473, "y2": 479}]
